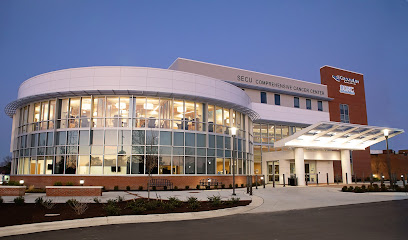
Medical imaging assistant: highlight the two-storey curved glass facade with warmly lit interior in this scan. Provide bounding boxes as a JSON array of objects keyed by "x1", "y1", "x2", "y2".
[{"x1": 13, "y1": 96, "x2": 253, "y2": 175}]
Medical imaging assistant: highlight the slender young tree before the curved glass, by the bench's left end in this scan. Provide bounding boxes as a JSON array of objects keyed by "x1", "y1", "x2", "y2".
[{"x1": 146, "y1": 129, "x2": 159, "y2": 200}]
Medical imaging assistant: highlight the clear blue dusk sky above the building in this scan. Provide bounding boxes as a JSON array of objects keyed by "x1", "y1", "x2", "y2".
[{"x1": 0, "y1": 0, "x2": 408, "y2": 158}]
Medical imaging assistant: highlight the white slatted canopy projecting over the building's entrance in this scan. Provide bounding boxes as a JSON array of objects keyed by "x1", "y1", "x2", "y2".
[{"x1": 274, "y1": 122, "x2": 404, "y2": 150}]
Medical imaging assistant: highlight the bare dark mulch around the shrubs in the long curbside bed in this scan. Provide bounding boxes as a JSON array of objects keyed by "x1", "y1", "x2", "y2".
[{"x1": 0, "y1": 200, "x2": 251, "y2": 227}]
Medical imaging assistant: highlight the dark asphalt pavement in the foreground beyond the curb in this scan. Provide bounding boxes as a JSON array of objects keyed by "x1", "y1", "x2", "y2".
[{"x1": 4, "y1": 200, "x2": 408, "y2": 240}]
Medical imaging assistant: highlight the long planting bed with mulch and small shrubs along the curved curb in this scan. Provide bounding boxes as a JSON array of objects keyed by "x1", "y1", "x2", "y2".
[{"x1": 0, "y1": 197, "x2": 251, "y2": 227}]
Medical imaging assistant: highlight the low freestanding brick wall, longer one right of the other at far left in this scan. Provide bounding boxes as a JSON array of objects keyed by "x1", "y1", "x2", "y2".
[{"x1": 46, "y1": 186, "x2": 102, "y2": 196}]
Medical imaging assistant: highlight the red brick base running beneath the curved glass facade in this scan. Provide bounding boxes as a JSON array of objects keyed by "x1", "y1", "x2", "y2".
[{"x1": 10, "y1": 175, "x2": 255, "y2": 190}]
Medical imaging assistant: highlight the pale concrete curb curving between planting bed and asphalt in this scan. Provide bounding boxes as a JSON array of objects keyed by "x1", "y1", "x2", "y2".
[{"x1": 0, "y1": 196, "x2": 263, "y2": 237}]
